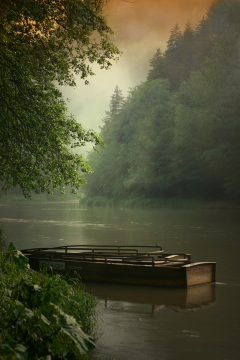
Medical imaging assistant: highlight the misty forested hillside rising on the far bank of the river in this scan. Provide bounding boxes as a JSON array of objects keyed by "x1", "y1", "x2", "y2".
[{"x1": 86, "y1": 0, "x2": 240, "y2": 201}]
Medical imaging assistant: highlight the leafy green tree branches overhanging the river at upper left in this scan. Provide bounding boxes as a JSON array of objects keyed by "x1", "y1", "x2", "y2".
[{"x1": 0, "y1": 0, "x2": 119, "y2": 196}]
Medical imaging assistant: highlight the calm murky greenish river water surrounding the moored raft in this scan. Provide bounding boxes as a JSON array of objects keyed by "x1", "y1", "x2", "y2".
[{"x1": 0, "y1": 201, "x2": 240, "y2": 360}]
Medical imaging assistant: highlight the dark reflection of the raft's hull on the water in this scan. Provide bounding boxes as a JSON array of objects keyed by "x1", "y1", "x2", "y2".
[{"x1": 86, "y1": 283, "x2": 216, "y2": 312}]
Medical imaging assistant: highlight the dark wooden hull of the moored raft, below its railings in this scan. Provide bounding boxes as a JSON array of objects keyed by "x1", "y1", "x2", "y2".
[{"x1": 25, "y1": 251, "x2": 216, "y2": 288}]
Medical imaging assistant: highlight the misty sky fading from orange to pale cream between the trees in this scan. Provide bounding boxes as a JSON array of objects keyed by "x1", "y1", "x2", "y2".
[{"x1": 61, "y1": 0, "x2": 213, "y2": 138}]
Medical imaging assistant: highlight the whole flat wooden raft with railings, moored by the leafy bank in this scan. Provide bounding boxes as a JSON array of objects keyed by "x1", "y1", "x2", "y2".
[{"x1": 22, "y1": 245, "x2": 216, "y2": 287}]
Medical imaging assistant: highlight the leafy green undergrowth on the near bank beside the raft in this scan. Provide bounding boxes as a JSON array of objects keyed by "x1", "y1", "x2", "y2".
[{"x1": 0, "y1": 244, "x2": 96, "y2": 360}]
